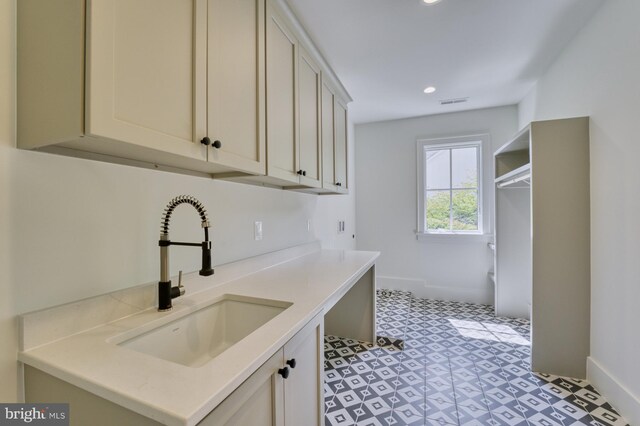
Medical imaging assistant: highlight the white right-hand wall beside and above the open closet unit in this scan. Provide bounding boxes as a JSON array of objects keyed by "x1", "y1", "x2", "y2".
[{"x1": 519, "y1": 0, "x2": 640, "y2": 424}]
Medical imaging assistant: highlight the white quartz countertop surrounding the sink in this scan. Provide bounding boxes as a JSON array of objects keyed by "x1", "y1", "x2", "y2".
[{"x1": 19, "y1": 246, "x2": 379, "y2": 425}]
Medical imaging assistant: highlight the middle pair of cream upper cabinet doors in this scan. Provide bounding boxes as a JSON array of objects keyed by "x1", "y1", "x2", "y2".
[{"x1": 266, "y1": 1, "x2": 322, "y2": 188}]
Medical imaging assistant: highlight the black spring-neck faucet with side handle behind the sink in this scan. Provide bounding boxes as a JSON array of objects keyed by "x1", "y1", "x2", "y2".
[{"x1": 158, "y1": 195, "x2": 213, "y2": 311}]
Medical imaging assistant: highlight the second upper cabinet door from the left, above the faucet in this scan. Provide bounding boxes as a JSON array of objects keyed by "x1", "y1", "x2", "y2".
[{"x1": 207, "y1": 0, "x2": 266, "y2": 174}]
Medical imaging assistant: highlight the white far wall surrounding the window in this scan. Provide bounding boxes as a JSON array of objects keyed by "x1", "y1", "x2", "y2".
[{"x1": 355, "y1": 106, "x2": 517, "y2": 303}]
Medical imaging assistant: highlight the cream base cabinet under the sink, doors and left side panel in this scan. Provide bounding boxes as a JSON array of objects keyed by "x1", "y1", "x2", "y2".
[{"x1": 25, "y1": 314, "x2": 324, "y2": 426}]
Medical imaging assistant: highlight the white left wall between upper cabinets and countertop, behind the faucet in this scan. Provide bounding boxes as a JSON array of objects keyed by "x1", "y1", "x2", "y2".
[{"x1": 0, "y1": 0, "x2": 355, "y2": 401}]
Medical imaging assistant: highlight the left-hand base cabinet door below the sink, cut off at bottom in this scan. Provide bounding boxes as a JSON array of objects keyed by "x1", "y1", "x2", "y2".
[{"x1": 198, "y1": 350, "x2": 282, "y2": 426}]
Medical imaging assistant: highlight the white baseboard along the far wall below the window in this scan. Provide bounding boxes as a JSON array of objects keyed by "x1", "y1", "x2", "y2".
[{"x1": 376, "y1": 275, "x2": 493, "y2": 305}]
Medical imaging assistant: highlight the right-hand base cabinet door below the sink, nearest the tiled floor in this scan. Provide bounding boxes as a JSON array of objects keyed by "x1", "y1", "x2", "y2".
[{"x1": 284, "y1": 314, "x2": 324, "y2": 426}]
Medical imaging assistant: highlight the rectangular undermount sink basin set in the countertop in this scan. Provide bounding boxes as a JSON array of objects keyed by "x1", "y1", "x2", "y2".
[{"x1": 118, "y1": 294, "x2": 291, "y2": 367}]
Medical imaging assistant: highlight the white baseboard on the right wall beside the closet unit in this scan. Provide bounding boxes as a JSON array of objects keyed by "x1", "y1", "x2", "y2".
[{"x1": 587, "y1": 357, "x2": 640, "y2": 425}]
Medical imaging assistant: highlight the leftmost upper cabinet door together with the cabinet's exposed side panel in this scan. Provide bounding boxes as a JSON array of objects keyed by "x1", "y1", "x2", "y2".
[{"x1": 18, "y1": 0, "x2": 211, "y2": 172}]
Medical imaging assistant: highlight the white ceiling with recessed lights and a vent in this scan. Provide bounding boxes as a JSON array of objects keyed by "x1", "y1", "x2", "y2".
[{"x1": 287, "y1": 0, "x2": 604, "y2": 123}]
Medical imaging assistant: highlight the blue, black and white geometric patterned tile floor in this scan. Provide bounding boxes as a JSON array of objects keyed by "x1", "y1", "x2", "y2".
[{"x1": 325, "y1": 290, "x2": 626, "y2": 426}]
